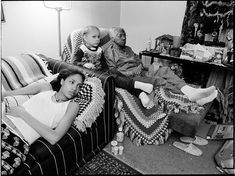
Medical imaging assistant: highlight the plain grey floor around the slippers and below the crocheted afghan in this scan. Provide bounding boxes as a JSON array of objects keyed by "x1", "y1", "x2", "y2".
[{"x1": 104, "y1": 132, "x2": 225, "y2": 174}]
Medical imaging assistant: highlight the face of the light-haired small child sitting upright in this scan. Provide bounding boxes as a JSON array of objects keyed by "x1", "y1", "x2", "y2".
[{"x1": 84, "y1": 29, "x2": 100, "y2": 47}]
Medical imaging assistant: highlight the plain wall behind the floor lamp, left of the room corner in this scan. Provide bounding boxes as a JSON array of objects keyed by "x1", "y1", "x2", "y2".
[{"x1": 1, "y1": 1, "x2": 120, "y2": 57}]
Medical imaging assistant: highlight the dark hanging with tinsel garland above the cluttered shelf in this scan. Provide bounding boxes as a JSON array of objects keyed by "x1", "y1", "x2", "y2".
[{"x1": 181, "y1": 0, "x2": 235, "y2": 46}]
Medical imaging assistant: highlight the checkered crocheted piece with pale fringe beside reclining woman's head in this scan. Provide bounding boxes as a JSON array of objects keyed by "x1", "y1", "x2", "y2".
[{"x1": 73, "y1": 77, "x2": 105, "y2": 132}]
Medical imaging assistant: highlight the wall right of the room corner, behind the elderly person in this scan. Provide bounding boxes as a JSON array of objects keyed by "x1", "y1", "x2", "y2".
[{"x1": 120, "y1": 1, "x2": 187, "y2": 53}]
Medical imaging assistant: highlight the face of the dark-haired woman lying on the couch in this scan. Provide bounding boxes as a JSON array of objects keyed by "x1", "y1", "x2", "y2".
[{"x1": 60, "y1": 74, "x2": 83, "y2": 99}]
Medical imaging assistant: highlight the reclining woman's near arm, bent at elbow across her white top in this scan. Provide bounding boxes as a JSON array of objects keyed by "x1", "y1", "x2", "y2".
[{"x1": 8, "y1": 100, "x2": 79, "y2": 145}]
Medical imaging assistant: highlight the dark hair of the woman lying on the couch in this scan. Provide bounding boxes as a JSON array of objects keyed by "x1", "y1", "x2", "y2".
[{"x1": 50, "y1": 69, "x2": 85, "y2": 92}]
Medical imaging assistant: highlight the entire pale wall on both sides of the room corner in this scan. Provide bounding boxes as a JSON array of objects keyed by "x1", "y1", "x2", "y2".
[{"x1": 1, "y1": 1, "x2": 186, "y2": 57}]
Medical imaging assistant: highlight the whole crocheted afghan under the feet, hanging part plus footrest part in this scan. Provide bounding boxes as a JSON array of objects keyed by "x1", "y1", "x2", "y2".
[{"x1": 115, "y1": 88, "x2": 203, "y2": 146}]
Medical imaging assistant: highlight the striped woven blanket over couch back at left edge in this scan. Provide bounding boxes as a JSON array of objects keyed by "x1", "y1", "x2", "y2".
[{"x1": 1, "y1": 54, "x2": 51, "y2": 91}]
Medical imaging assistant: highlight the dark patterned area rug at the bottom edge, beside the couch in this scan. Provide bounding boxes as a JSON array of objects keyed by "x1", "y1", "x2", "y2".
[{"x1": 74, "y1": 151, "x2": 141, "y2": 175}]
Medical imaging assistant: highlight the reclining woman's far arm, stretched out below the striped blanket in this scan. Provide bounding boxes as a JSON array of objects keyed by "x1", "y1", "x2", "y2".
[{"x1": 2, "y1": 82, "x2": 52, "y2": 100}]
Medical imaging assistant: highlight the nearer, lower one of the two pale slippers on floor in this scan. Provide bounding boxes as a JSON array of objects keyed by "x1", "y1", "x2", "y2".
[{"x1": 173, "y1": 142, "x2": 202, "y2": 156}]
